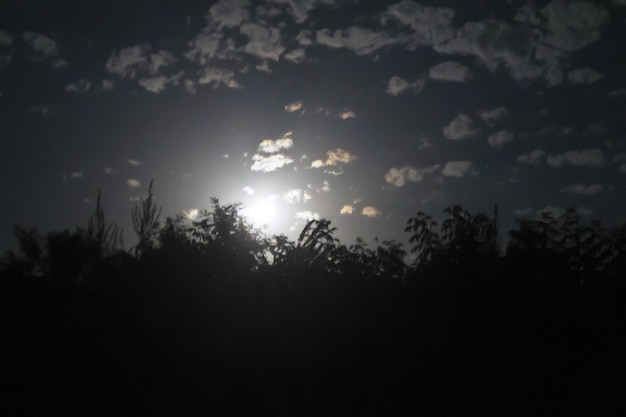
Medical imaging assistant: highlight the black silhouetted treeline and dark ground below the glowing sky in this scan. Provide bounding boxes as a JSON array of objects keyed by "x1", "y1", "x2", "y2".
[{"x1": 0, "y1": 187, "x2": 626, "y2": 416}]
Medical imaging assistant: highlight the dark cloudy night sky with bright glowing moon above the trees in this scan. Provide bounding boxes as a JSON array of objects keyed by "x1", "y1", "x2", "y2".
[{"x1": 0, "y1": 0, "x2": 626, "y2": 248}]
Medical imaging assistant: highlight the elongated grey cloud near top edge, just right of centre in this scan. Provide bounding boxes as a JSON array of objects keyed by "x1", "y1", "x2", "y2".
[{"x1": 316, "y1": 26, "x2": 403, "y2": 55}]
